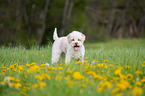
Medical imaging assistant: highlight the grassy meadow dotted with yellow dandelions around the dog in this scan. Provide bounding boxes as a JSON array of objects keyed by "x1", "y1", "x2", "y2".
[{"x1": 0, "y1": 39, "x2": 145, "y2": 96}]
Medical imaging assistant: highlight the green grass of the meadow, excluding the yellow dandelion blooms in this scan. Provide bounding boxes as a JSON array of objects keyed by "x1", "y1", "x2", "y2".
[{"x1": 0, "y1": 39, "x2": 145, "y2": 96}]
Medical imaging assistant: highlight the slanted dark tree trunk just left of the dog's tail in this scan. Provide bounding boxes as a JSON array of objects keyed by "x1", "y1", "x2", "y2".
[{"x1": 37, "y1": 0, "x2": 50, "y2": 46}]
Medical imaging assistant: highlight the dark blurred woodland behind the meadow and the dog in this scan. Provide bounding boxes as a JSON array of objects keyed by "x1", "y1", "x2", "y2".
[{"x1": 0, "y1": 0, "x2": 145, "y2": 46}]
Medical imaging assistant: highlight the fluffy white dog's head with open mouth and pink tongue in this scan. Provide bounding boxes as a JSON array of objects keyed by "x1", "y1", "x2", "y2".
[{"x1": 67, "y1": 31, "x2": 86, "y2": 51}]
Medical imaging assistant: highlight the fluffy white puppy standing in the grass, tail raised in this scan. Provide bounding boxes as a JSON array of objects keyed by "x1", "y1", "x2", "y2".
[{"x1": 51, "y1": 28, "x2": 85, "y2": 64}]
